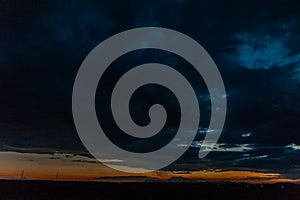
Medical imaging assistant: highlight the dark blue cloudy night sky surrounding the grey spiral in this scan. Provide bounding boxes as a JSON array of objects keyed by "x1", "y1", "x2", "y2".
[{"x1": 0, "y1": 0, "x2": 300, "y2": 181}]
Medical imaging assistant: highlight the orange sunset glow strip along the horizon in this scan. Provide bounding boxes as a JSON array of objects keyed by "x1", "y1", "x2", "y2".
[{"x1": 0, "y1": 152, "x2": 299, "y2": 183}]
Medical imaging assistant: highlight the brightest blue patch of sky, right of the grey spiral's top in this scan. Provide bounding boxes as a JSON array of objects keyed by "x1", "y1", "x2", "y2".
[{"x1": 234, "y1": 32, "x2": 300, "y2": 69}]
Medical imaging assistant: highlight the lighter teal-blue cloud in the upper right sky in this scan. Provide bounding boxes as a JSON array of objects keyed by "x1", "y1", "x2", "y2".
[{"x1": 230, "y1": 20, "x2": 300, "y2": 69}]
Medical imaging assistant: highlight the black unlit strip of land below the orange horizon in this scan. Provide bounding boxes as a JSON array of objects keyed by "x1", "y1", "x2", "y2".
[{"x1": 0, "y1": 180, "x2": 300, "y2": 200}]
